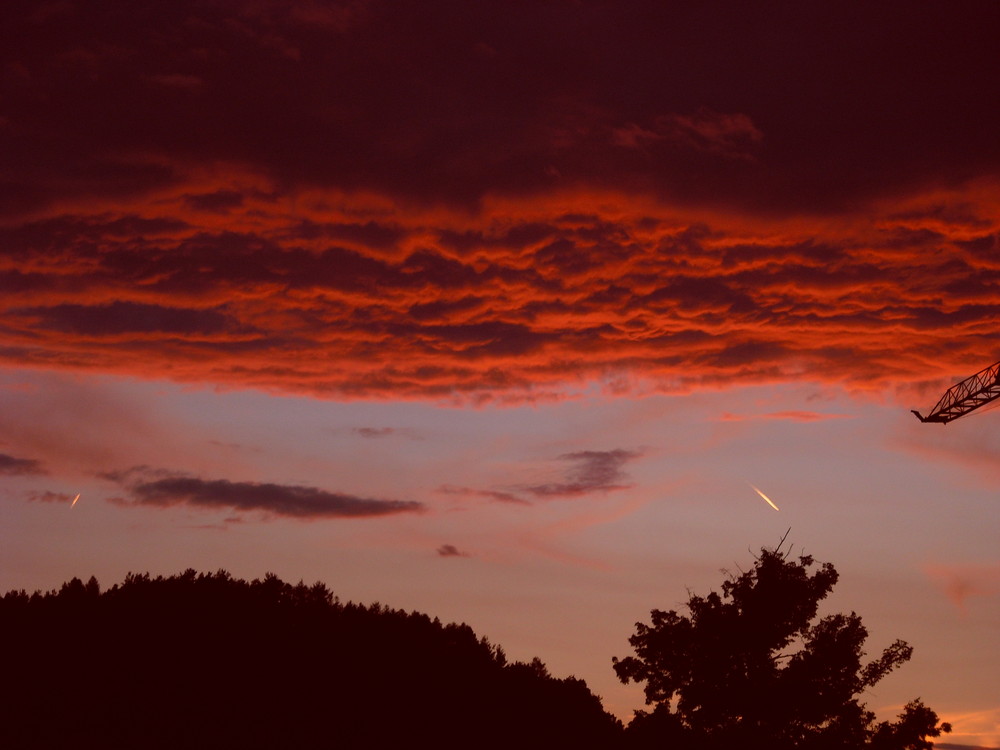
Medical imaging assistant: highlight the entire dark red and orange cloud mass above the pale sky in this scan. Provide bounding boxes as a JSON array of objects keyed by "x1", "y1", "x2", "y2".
[{"x1": 0, "y1": 0, "x2": 1000, "y2": 402}]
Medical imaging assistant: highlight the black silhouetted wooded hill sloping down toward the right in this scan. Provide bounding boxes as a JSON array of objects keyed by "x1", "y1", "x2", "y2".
[{"x1": 0, "y1": 570, "x2": 622, "y2": 750}]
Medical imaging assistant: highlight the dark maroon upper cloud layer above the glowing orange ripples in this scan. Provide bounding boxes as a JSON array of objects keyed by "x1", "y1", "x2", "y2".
[{"x1": 0, "y1": 0, "x2": 1000, "y2": 211}]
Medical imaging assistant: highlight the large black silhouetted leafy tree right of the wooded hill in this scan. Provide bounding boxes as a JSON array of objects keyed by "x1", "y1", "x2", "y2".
[{"x1": 613, "y1": 539, "x2": 951, "y2": 750}]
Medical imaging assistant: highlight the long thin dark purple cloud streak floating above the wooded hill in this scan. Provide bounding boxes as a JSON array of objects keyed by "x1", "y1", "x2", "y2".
[{"x1": 103, "y1": 467, "x2": 423, "y2": 518}]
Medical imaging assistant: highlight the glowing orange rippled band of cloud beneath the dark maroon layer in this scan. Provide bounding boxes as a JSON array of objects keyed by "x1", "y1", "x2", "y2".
[{"x1": 0, "y1": 180, "x2": 1000, "y2": 406}]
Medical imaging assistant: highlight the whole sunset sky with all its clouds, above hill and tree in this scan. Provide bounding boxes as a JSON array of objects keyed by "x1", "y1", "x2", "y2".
[{"x1": 0, "y1": 0, "x2": 1000, "y2": 746}]
